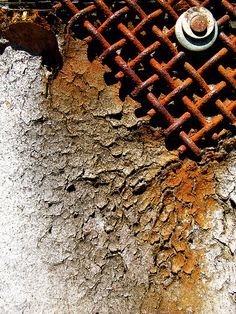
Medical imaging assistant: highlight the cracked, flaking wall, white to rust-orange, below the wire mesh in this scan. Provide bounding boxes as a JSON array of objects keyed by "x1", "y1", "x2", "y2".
[{"x1": 0, "y1": 35, "x2": 236, "y2": 314}]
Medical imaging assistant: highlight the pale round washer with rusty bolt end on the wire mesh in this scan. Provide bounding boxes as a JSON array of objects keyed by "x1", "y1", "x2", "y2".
[{"x1": 175, "y1": 7, "x2": 218, "y2": 51}]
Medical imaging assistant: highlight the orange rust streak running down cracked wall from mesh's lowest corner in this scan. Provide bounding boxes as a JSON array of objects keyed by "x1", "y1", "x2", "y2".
[{"x1": 138, "y1": 160, "x2": 216, "y2": 314}]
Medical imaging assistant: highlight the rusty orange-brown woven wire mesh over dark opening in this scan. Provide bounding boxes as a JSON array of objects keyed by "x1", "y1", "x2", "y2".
[{"x1": 56, "y1": 0, "x2": 236, "y2": 156}]
